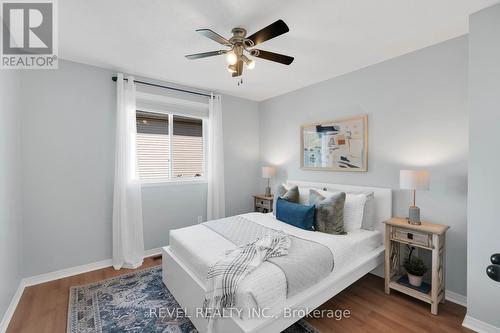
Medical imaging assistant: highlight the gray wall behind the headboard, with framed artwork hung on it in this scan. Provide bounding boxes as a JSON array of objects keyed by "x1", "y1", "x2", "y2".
[{"x1": 260, "y1": 37, "x2": 468, "y2": 295}]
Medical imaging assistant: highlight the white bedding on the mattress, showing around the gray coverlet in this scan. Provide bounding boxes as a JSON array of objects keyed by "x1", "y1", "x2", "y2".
[{"x1": 170, "y1": 213, "x2": 383, "y2": 318}]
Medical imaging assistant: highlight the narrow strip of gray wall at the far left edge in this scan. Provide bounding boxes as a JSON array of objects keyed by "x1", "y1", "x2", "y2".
[{"x1": 0, "y1": 71, "x2": 23, "y2": 316}]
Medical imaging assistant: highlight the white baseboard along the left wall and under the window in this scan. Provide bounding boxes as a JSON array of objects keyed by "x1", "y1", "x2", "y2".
[{"x1": 0, "y1": 248, "x2": 161, "y2": 333}]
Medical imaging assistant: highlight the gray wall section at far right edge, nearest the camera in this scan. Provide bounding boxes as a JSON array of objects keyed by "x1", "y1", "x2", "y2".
[{"x1": 467, "y1": 5, "x2": 500, "y2": 330}]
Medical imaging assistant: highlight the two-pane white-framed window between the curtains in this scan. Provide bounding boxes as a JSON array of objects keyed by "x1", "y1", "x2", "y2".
[{"x1": 136, "y1": 110, "x2": 205, "y2": 182}]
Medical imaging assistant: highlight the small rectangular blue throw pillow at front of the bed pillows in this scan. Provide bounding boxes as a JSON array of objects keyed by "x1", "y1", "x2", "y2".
[{"x1": 276, "y1": 198, "x2": 316, "y2": 230}]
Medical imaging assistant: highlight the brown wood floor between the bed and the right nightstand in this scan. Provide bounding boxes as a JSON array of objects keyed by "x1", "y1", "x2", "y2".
[{"x1": 308, "y1": 274, "x2": 474, "y2": 333}]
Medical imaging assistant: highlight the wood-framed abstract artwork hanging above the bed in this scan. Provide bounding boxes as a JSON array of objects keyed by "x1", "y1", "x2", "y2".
[{"x1": 300, "y1": 115, "x2": 368, "y2": 171}]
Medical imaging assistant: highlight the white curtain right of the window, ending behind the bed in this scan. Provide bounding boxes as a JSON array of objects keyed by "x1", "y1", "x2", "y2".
[{"x1": 207, "y1": 95, "x2": 226, "y2": 220}]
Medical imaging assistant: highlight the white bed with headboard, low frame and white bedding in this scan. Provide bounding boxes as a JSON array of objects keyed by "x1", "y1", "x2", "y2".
[{"x1": 162, "y1": 181, "x2": 392, "y2": 333}]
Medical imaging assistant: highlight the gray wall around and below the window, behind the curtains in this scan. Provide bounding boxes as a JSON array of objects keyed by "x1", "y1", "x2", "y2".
[{"x1": 18, "y1": 61, "x2": 259, "y2": 276}]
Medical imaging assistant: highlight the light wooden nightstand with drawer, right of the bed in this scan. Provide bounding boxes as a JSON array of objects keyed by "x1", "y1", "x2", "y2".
[{"x1": 384, "y1": 218, "x2": 449, "y2": 315}]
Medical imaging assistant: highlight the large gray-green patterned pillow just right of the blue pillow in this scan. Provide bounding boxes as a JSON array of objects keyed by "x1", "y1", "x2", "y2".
[{"x1": 309, "y1": 189, "x2": 346, "y2": 235}]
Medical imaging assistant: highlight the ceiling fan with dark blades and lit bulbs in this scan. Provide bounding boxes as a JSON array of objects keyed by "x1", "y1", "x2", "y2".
[{"x1": 186, "y1": 20, "x2": 293, "y2": 77}]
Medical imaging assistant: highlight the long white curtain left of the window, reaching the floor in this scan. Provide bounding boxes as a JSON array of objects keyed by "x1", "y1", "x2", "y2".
[{"x1": 113, "y1": 74, "x2": 144, "y2": 269}]
